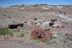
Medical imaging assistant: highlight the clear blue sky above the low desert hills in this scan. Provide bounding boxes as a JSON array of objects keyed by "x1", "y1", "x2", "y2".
[{"x1": 0, "y1": 0, "x2": 72, "y2": 7}]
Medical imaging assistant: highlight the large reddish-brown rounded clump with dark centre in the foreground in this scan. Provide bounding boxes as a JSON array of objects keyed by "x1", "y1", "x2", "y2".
[{"x1": 31, "y1": 28, "x2": 53, "y2": 41}]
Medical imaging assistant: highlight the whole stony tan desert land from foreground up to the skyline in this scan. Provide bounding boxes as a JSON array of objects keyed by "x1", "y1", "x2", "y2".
[{"x1": 0, "y1": 4, "x2": 72, "y2": 48}]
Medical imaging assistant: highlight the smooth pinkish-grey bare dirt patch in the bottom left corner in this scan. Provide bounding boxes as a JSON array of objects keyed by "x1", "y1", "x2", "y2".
[{"x1": 0, "y1": 40, "x2": 37, "y2": 48}]
